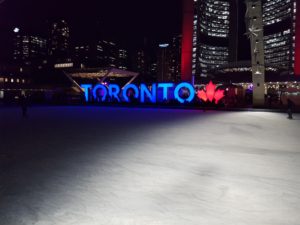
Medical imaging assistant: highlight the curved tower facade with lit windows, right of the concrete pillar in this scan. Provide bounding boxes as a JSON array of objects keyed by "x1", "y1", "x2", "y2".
[{"x1": 262, "y1": 0, "x2": 300, "y2": 75}]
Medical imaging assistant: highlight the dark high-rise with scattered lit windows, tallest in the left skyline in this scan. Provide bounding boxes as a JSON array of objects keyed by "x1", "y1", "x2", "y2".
[{"x1": 49, "y1": 20, "x2": 71, "y2": 63}]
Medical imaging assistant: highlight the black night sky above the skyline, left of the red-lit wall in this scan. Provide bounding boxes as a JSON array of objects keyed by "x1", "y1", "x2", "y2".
[{"x1": 0, "y1": 0, "x2": 181, "y2": 47}]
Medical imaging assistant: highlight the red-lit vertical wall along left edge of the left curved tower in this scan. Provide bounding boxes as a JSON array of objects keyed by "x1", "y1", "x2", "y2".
[{"x1": 181, "y1": 0, "x2": 194, "y2": 82}]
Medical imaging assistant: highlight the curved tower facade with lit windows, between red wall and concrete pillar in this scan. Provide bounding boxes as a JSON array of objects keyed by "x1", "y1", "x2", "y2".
[{"x1": 192, "y1": 0, "x2": 236, "y2": 80}]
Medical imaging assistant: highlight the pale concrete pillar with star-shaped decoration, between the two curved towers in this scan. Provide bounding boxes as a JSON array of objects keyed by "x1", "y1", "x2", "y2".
[{"x1": 245, "y1": 0, "x2": 265, "y2": 106}]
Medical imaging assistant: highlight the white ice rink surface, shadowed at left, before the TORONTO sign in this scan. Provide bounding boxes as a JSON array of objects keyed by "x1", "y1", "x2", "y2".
[{"x1": 0, "y1": 107, "x2": 300, "y2": 225}]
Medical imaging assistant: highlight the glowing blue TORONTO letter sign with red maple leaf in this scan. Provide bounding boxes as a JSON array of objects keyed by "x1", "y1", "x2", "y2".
[{"x1": 81, "y1": 82, "x2": 224, "y2": 104}]
